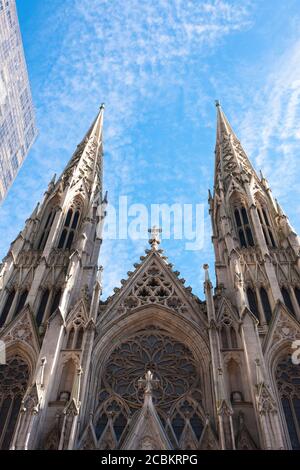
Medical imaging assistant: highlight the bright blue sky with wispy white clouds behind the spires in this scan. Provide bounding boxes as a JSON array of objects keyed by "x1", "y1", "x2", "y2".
[{"x1": 0, "y1": 0, "x2": 300, "y2": 298}]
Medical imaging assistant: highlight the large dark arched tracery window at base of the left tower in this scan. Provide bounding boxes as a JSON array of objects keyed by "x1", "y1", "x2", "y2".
[{"x1": 0, "y1": 357, "x2": 29, "y2": 450}]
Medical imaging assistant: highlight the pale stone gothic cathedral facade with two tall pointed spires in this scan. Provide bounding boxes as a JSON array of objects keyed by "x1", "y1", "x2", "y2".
[{"x1": 0, "y1": 104, "x2": 300, "y2": 450}]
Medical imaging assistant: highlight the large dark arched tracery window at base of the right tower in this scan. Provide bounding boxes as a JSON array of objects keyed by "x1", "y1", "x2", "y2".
[{"x1": 276, "y1": 357, "x2": 300, "y2": 450}]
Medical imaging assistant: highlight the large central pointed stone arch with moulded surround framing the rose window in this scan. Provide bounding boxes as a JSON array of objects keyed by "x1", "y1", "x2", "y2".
[{"x1": 82, "y1": 306, "x2": 212, "y2": 448}]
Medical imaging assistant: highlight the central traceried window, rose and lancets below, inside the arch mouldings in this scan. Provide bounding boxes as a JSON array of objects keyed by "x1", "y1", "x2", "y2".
[{"x1": 95, "y1": 325, "x2": 209, "y2": 449}]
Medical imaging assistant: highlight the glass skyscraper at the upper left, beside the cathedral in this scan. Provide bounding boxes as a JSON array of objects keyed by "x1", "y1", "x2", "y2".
[{"x1": 0, "y1": 0, "x2": 37, "y2": 203}]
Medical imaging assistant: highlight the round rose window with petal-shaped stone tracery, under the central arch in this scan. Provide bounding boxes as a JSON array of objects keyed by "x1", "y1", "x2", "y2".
[{"x1": 103, "y1": 327, "x2": 200, "y2": 408}]
